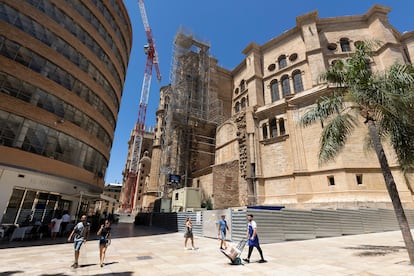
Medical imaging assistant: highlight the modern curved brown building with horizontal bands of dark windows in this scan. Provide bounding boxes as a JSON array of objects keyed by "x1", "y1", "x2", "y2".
[{"x1": 0, "y1": 0, "x2": 132, "y2": 223}]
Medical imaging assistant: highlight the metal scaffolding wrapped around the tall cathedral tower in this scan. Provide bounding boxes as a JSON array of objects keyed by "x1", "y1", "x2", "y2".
[{"x1": 159, "y1": 28, "x2": 224, "y2": 193}]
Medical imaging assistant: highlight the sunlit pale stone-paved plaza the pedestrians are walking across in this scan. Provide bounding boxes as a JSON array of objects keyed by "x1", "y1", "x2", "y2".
[{"x1": 0, "y1": 223, "x2": 414, "y2": 276}]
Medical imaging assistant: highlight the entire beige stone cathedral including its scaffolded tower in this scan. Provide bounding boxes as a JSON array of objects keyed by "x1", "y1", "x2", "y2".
[{"x1": 134, "y1": 5, "x2": 414, "y2": 209}]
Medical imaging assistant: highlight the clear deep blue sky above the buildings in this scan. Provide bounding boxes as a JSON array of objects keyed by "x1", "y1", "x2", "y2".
[{"x1": 105, "y1": 0, "x2": 414, "y2": 184}]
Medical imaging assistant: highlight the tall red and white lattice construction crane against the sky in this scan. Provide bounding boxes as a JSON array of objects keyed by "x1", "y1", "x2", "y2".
[{"x1": 124, "y1": 0, "x2": 161, "y2": 213}]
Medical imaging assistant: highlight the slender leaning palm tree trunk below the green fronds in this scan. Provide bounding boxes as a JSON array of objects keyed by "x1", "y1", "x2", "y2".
[{"x1": 368, "y1": 120, "x2": 414, "y2": 265}]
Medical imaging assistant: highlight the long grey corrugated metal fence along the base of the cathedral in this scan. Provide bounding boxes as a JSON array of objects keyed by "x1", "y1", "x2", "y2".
[{"x1": 135, "y1": 208, "x2": 414, "y2": 244}]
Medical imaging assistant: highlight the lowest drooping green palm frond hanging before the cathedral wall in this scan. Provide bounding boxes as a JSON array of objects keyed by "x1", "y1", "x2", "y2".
[{"x1": 319, "y1": 113, "x2": 357, "y2": 163}]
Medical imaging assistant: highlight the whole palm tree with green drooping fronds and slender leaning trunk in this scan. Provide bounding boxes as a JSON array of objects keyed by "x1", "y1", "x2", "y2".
[{"x1": 300, "y1": 41, "x2": 414, "y2": 264}]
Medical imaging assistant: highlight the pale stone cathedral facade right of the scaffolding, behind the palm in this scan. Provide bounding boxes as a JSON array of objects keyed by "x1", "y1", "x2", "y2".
[{"x1": 151, "y1": 5, "x2": 414, "y2": 209}]
